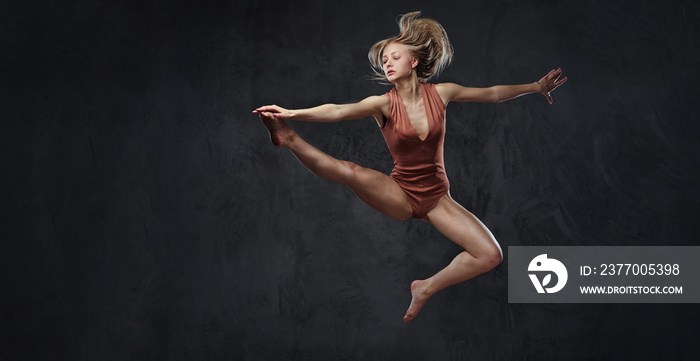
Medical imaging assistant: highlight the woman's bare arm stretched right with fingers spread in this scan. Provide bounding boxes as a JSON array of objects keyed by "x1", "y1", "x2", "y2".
[{"x1": 439, "y1": 69, "x2": 567, "y2": 104}]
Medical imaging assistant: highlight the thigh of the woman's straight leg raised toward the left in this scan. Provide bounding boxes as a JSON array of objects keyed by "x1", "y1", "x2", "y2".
[{"x1": 347, "y1": 163, "x2": 413, "y2": 220}]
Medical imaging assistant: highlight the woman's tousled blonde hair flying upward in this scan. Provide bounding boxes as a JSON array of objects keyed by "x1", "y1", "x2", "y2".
[{"x1": 367, "y1": 11, "x2": 454, "y2": 83}]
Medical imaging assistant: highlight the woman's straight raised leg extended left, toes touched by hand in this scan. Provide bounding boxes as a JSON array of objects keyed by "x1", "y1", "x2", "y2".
[{"x1": 260, "y1": 116, "x2": 413, "y2": 220}]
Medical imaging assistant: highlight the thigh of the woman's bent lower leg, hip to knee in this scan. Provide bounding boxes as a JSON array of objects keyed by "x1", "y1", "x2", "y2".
[{"x1": 424, "y1": 193, "x2": 502, "y2": 258}]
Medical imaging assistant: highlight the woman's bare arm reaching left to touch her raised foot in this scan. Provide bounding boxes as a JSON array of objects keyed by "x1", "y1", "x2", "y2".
[{"x1": 253, "y1": 96, "x2": 389, "y2": 122}]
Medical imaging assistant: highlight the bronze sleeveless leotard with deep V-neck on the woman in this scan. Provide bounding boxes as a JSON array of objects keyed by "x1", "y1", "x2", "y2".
[{"x1": 382, "y1": 83, "x2": 450, "y2": 219}]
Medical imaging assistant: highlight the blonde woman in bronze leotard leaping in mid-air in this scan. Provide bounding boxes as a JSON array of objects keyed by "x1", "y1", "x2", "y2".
[{"x1": 253, "y1": 12, "x2": 566, "y2": 322}]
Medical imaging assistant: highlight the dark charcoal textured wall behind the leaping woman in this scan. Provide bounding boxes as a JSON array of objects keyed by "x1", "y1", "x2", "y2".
[{"x1": 0, "y1": 1, "x2": 700, "y2": 360}]
